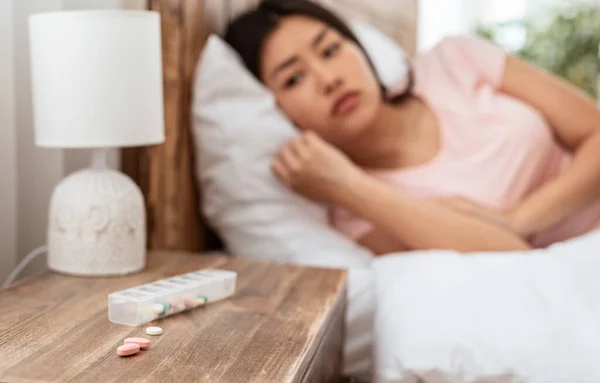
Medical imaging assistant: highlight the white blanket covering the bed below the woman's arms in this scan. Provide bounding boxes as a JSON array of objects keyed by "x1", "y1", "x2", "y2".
[{"x1": 373, "y1": 231, "x2": 600, "y2": 383}]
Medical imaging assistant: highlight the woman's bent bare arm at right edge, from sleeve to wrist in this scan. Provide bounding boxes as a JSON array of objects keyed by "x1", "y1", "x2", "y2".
[{"x1": 500, "y1": 56, "x2": 600, "y2": 235}]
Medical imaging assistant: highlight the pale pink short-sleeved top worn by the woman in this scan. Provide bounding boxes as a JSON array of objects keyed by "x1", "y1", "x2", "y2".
[{"x1": 332, "y1": 37, "x2": 600, "y2": 247}]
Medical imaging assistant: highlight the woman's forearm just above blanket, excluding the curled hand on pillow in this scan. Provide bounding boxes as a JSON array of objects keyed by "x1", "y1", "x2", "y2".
[{"x1": 338, "y1": 174, "x2": 530, "y2": 254}]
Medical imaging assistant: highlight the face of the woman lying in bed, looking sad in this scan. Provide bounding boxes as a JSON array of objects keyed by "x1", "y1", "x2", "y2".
[{"x1": 260, "y1": 16, "x2": 382, "y2": 146}]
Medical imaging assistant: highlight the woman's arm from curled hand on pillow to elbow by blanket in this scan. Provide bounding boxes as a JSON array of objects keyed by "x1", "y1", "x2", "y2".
[{"x1": 273, "y1": 132, "x2": 529, "y2": 253}]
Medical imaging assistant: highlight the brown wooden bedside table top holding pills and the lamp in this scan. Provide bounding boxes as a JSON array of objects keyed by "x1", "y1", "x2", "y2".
[{"x1": 0, "y1": 252, "x2": 346, "y2": 383}]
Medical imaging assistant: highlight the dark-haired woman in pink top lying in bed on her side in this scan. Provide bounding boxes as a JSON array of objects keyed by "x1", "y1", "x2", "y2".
[{"x1": 226, "y1": 0, "x2": 600, "y2": 254}]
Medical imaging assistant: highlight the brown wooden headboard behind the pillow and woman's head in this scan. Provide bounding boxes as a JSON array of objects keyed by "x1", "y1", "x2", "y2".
[{"x1": 121, "y1": 0, "x2": 418, "y2": 251}]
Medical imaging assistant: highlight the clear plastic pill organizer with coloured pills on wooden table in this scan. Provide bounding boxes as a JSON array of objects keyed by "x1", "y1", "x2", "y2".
[{"x1": 108, "y1": 269, "x2": 237, "y2": 326}]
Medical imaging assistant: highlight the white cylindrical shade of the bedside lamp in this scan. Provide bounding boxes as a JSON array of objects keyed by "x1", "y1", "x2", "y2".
[{"x1": 29, "y1": 10, "x2": 165, "y2": 148}]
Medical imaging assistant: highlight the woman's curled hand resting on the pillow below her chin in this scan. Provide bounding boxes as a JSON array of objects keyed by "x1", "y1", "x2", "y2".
[{"x1": 273, "y1": 132, "x2": 363, "y2": 204}]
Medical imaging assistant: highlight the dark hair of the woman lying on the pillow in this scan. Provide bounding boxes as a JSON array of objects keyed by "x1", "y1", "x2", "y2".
[{"x1": 225, "y1": 0, "x2": 414, "y2": 103}]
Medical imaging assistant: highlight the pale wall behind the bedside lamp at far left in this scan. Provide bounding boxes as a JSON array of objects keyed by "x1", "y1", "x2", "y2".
[{"x1": 0, "y1": 0, "x2": 145, "y2": 284}]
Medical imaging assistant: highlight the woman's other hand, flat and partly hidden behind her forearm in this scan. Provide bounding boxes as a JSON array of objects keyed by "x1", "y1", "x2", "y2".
[{"x1": 435, "y1": 196, "x2": 533, "y2": 238}]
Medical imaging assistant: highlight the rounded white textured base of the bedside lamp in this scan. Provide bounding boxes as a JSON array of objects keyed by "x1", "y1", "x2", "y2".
[{"x1": 48, "y1": 168, "x2": 146, "y2": 276}]
